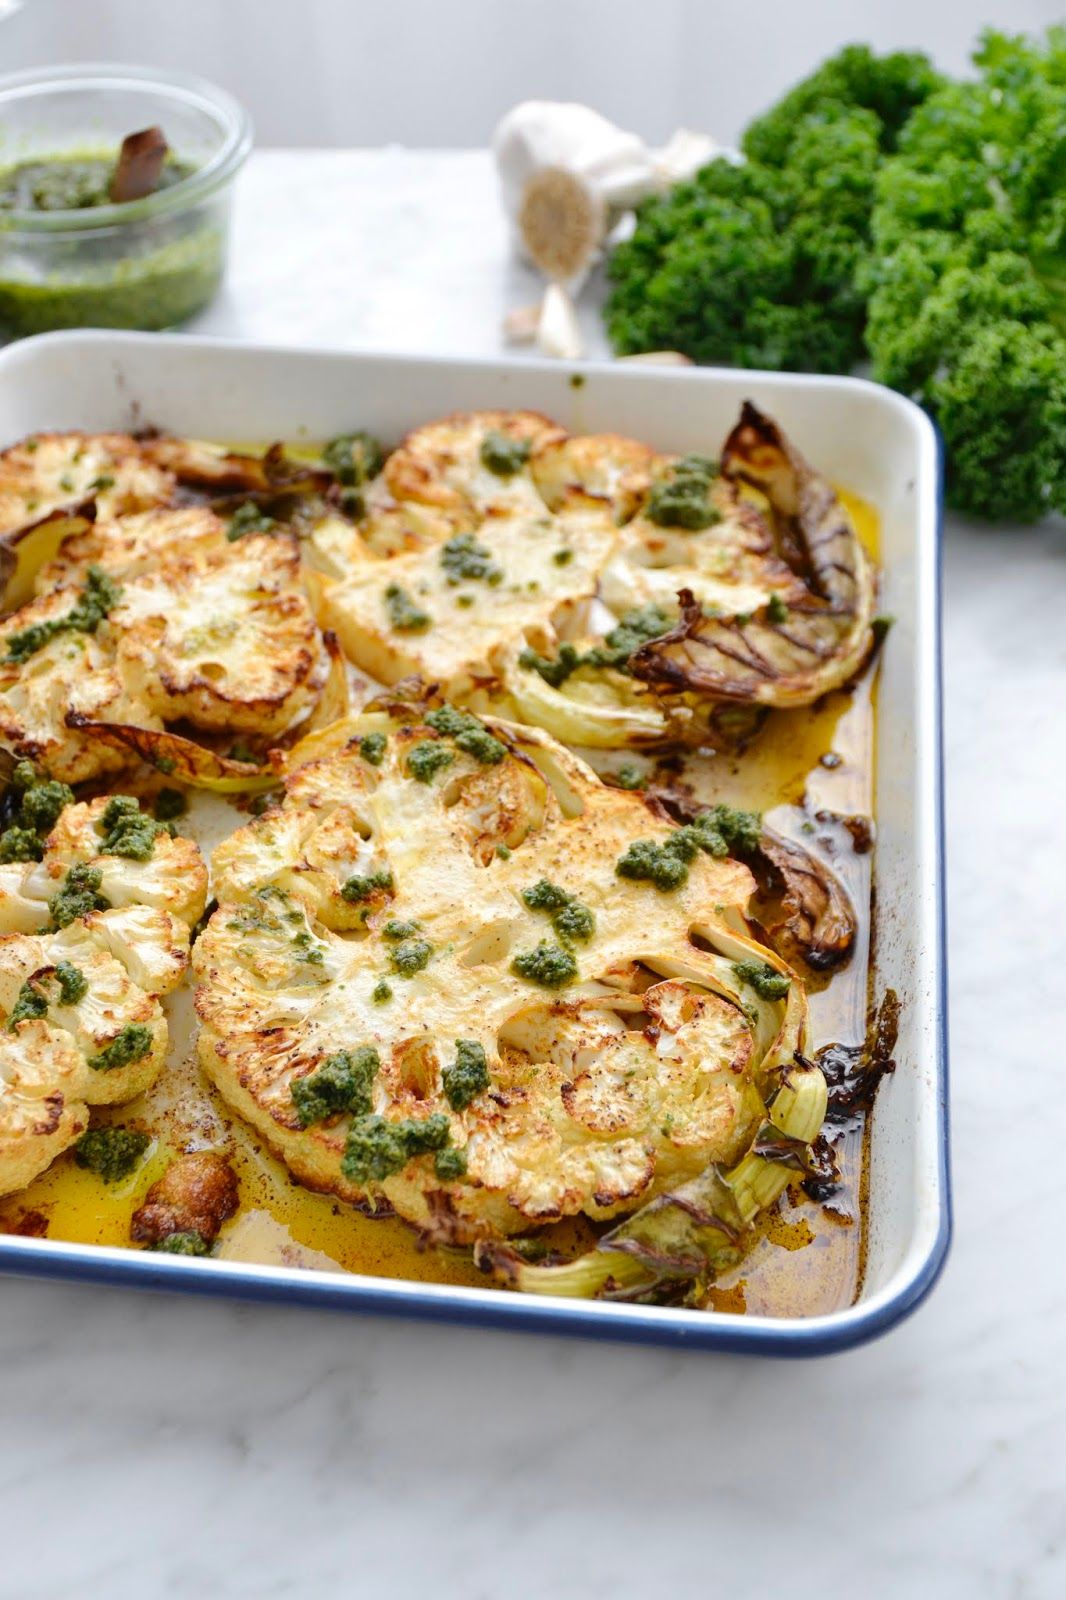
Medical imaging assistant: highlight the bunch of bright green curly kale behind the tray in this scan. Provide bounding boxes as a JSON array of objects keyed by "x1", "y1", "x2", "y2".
[{"x1": 607, "y1": 29, "x2": 1066, "y2": 520}]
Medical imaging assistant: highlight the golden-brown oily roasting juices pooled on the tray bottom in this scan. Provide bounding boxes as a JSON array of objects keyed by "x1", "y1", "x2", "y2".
[{"x1": 0, "y1": 493, "x2": 877, "y2": 1317}]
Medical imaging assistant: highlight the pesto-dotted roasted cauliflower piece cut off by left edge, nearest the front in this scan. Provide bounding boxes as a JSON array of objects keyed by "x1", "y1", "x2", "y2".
[{"x1": 0, "y1": 798, "x2": 206, "y2": 1194}]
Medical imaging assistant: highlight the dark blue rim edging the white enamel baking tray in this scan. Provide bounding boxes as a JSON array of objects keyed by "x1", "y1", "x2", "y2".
[{"x1": 0, "y1": 330, "x2": 952, "y2": 1357}]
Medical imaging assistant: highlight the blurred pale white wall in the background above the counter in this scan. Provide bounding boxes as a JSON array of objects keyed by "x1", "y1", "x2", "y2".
[{"x1": 0, "y1": 0, "x2": 1063, "y2": 146}]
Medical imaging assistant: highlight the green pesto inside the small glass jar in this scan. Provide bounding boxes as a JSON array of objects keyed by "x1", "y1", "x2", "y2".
[{"x1": 0, "y1": 155, "x2": 224, "y2": 338}]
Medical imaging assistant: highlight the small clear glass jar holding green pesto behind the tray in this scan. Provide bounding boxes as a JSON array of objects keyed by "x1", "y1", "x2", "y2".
[{"x1": 0, "y1": 64, "x2": 251, "y2": 338}]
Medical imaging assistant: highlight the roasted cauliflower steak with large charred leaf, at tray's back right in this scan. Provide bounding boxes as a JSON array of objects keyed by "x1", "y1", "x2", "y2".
[{"x1": 311, "y1": 405, "x2": 874, "y2": 749}]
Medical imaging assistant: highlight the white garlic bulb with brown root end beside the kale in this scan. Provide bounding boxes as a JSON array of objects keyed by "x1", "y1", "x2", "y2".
[{"x1": 493, "y1": 101, "x2": 717, "y2": 294}]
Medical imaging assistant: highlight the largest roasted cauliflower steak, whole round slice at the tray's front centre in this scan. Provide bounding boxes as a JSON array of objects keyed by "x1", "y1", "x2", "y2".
[{"x1": 194, "y1": 694, "x2": 805, "y2": 1243}]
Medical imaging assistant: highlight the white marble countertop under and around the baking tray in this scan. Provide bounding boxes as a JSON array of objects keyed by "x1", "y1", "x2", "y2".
[{"x1": 0, "y1": 152, "x2": 1066, "y2": 1600}]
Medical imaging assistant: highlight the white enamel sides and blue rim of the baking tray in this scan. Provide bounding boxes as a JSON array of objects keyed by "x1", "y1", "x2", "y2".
[{"x1": 0, "y1": 331, "x2": 951, "y2": 1355}]
